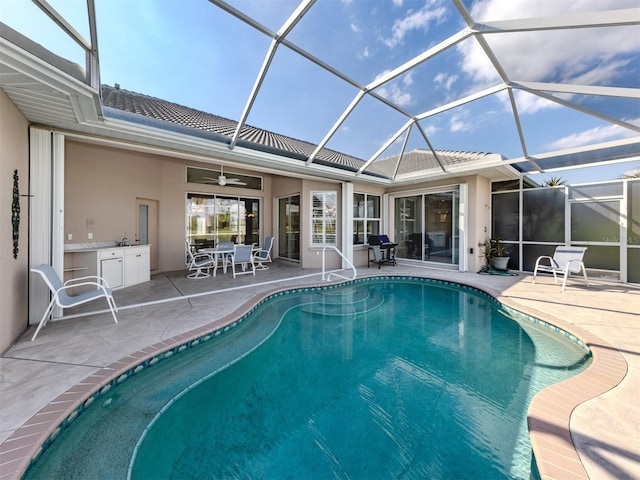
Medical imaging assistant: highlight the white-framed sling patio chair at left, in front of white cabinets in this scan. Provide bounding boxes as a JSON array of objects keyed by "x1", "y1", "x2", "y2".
[{"x1": 31, "y1": 264, "x2": 118, "y2": 342}]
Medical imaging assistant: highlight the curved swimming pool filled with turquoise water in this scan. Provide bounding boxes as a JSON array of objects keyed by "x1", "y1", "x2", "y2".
[{"x1": 26, "y1": 278, "x2": 589, "y2": 478}]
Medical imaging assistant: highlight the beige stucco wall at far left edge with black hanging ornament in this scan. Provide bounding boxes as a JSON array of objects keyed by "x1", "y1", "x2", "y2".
[{"x1": 0, "y1": 89, "x2": 29, "y2": 353}]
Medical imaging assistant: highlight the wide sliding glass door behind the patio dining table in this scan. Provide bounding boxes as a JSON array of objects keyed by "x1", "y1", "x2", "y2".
[{"x1": 186, "y1": 193, "x2": 260, "y2": 248}]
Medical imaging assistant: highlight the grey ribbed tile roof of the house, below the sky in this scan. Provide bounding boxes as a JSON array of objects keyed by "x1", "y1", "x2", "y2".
[{"x1": 102, "y1": 84, "x2": 502, "y2": 178}]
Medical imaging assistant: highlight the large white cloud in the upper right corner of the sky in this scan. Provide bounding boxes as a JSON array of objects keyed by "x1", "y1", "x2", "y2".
[{"x1": 458, "y1": 0, "x2": 638, "y2": 89}]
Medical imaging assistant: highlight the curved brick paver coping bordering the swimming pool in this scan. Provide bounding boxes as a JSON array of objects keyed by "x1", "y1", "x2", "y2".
[{"x1": 0, "y1": 273, "x2": 628, "y2": 480}]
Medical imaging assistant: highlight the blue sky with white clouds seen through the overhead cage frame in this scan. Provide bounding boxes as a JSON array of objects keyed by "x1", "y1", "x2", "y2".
[{"x1": 0, "y1": 0, "x2": 640, "y2": 183}]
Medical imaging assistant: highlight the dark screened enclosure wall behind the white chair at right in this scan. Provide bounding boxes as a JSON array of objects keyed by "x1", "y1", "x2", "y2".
[{"x1": 492, "y1": 179, "x2": 640, "y2": 283}]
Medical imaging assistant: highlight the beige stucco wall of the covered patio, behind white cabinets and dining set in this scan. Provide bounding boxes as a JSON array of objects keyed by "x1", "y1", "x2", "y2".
[{"x1": 65, "y1": 141, "x2": 273, "y2": 271}]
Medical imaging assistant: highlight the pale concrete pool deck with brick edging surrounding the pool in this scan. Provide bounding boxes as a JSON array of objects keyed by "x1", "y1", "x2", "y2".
[{"x1": 0, "y1": 261, "x2": 640, "y2": 480}]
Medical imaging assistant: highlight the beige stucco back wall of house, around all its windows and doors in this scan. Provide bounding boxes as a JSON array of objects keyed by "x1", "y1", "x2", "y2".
[{"x1": 64, "y1": 140, "x2": 490, "y2": 271}]
